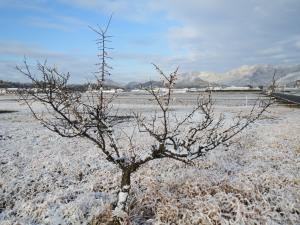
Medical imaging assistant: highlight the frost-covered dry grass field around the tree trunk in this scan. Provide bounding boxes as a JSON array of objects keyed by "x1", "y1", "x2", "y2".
[{"x1": 0, "y1": 93, "x2": 300, "y2": 225}]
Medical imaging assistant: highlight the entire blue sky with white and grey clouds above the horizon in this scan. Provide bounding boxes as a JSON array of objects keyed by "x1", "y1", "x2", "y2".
[{"x1": 0, "y1": 0, "x2": 300, "y2": 83}]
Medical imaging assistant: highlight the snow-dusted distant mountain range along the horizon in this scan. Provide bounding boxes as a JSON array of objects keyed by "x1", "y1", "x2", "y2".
[{"x1": 0, "y1": 64, "x2": 300, "y2": 90}]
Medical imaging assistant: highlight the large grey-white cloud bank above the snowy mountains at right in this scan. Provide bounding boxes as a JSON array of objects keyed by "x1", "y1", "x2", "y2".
[{"x1": 157, "y1": 0, "x2": 300, "y2": 71}]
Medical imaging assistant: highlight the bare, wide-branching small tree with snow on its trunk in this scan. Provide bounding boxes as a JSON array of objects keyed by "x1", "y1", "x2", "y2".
[{"x1": 17, "y1": 17, "x2": 272, "y2": 222}]
